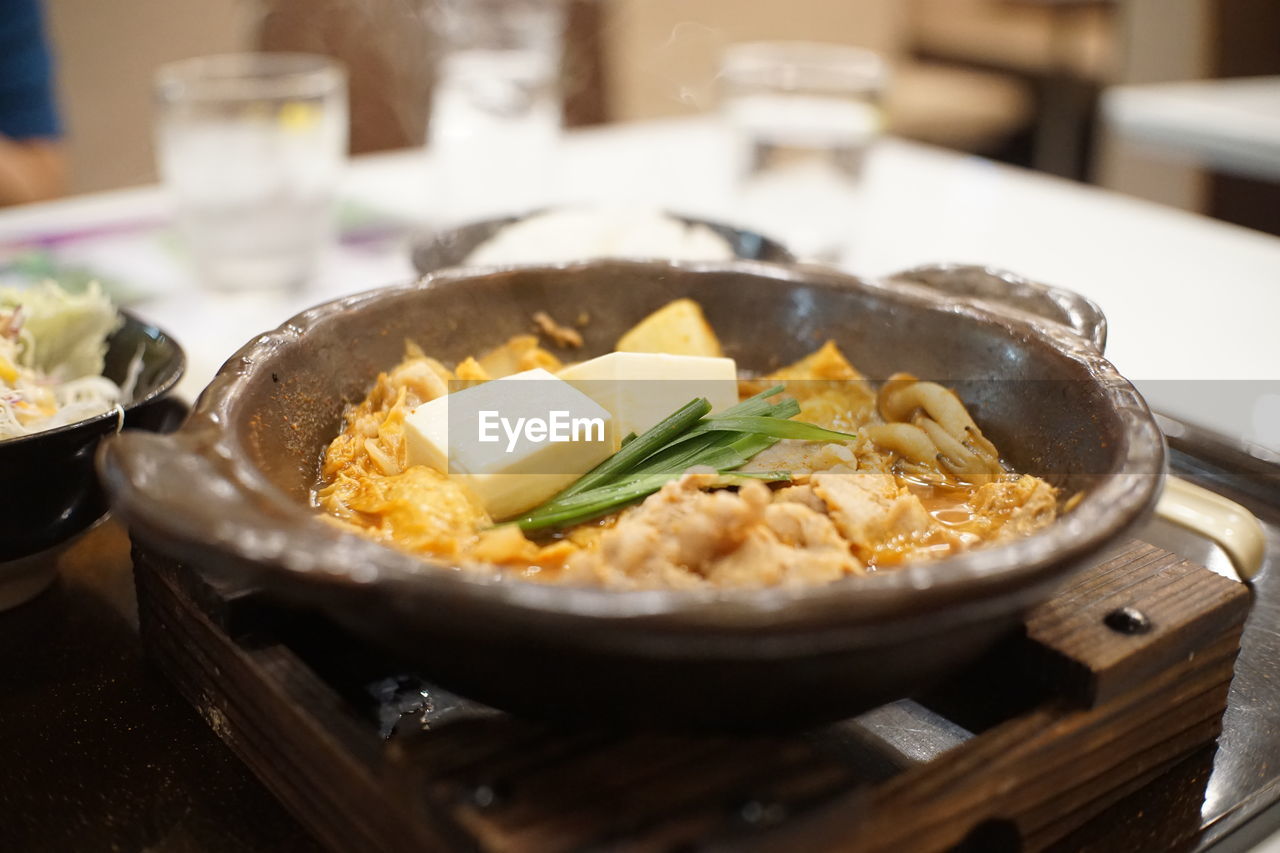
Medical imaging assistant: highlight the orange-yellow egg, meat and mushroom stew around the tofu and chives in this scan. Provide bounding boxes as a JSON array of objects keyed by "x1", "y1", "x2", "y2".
[{"x1": 315, "y1": 300, "x2": 1059, "y2": 589}]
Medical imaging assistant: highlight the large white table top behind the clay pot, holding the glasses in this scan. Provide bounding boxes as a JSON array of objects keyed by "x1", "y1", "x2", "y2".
[{"x1": 0, "y1": 119, "x2": 1280, "y2": 450}]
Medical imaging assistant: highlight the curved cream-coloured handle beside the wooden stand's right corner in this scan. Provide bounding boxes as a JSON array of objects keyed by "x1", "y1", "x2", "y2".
[{"x1": 1156, "y1": 476, "x2": 1267, "y2": 583}]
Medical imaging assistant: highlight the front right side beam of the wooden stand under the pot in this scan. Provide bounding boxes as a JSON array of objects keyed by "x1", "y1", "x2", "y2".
[{"x1": 747, "y1": 625, "x2": 1240, "y2": 853}]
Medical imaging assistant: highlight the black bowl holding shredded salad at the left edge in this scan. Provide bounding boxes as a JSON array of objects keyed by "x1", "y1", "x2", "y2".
[{"x1": 0, "y1": 311, "x2": 186, "y2": 562}]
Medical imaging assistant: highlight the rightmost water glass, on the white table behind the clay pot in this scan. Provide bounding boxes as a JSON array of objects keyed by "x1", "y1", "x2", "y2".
[{"x1": 719, "y1": 42, "x2": 887, "y2": 261}]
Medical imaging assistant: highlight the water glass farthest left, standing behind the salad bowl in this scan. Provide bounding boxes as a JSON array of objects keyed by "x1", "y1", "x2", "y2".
[{"x1": 155, "y1": 54, "x2": 348, "y2": 291}]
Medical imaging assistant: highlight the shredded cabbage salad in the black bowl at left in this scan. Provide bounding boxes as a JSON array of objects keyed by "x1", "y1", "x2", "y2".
[{"x1": 0, "y1": 282, "x2": 126, "y2": 441}]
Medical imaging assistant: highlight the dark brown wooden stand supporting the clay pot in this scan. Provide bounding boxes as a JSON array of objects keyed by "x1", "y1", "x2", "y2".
[{"x1": 134, "y1": 540, "x2": 1249, "y2": 853}]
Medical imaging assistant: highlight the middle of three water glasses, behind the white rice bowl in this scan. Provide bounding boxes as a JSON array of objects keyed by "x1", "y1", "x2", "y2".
[{"x1": 428, "y1": 0, "x2": 563, "y2": 219}]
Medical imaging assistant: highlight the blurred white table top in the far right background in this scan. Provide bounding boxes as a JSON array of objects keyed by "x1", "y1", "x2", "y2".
[{"x1": 1102, "y1": 77, "x2": 1280, "y2": 181}]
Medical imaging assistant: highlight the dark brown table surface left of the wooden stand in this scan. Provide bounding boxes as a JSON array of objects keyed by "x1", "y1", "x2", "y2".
[{"x1": 0, "y1": 521, "x2": 319, "y2": 850}]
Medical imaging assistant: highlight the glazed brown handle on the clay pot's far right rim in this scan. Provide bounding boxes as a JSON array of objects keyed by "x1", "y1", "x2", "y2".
[{"x1": 888, "y1": 264, "x2": 1107, "y2": 352}]
